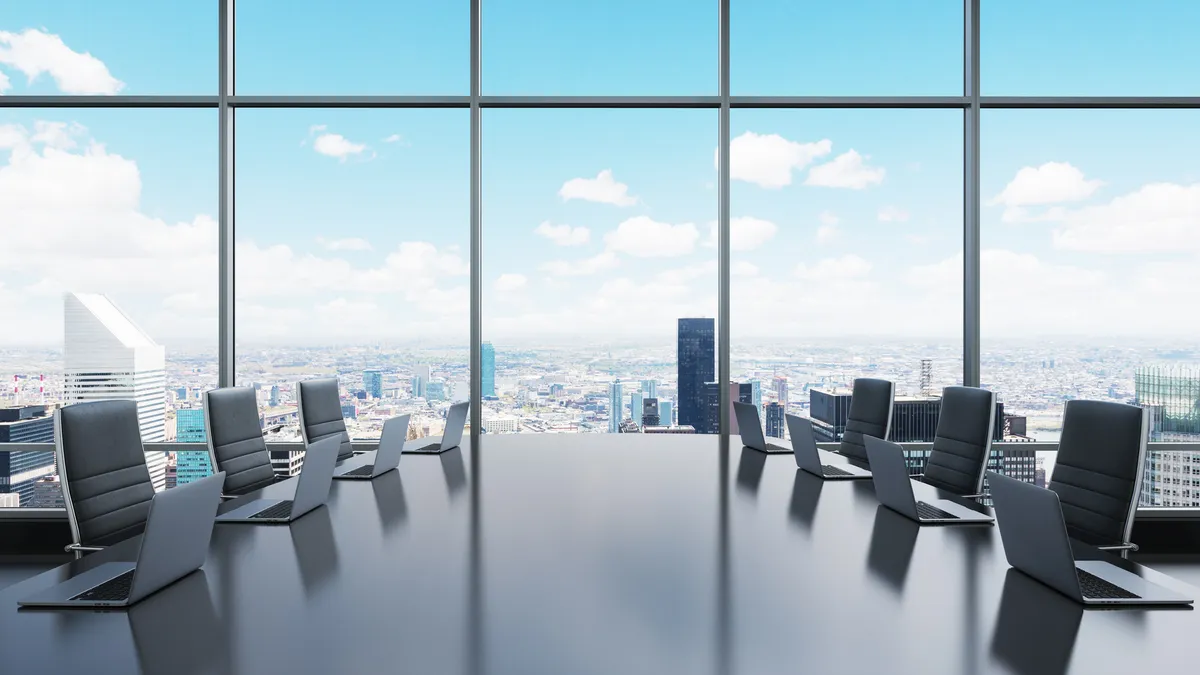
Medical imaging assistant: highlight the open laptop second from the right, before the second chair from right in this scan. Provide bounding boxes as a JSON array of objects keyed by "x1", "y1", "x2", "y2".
[{"x1": 863, "y1": 436, "x2": 995, "y2": 525}]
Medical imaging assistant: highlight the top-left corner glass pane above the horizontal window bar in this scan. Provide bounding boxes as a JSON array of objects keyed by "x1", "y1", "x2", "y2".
[{"x1": 0, "y1": 0, "x2": 218, "y2": 96}]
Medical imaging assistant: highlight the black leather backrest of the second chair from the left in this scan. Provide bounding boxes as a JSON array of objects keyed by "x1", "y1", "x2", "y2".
[{"x1": 204, "y1": 387, "x2": 275, "y2": 495}]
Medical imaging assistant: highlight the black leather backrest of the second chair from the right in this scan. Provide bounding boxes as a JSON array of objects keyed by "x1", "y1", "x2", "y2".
[{"x1": 922, "y1": 387, "x2": 996, "y2": 495}]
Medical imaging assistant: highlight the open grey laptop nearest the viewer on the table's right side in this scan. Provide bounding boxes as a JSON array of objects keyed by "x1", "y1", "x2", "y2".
[{"x1": 988, "y1": 471, "x2": 1192, "y2": 605}]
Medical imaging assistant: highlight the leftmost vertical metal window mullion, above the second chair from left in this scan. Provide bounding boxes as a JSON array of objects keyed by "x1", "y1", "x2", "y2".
[{"x1": 217, "y1": 0, "x2": 236, "y2": 387}]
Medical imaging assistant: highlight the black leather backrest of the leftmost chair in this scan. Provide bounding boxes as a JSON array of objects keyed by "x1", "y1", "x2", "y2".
[{"x1": 54, "y1": 401, "x2": 154, "y2": 546}]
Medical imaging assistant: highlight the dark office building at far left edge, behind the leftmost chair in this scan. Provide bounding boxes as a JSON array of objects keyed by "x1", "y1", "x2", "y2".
[{"x1": 0, "y1": 406, "x2": 54, "y2": 507}]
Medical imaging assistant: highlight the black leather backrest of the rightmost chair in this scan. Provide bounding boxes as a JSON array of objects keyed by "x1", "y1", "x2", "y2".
[{"x1": 1048, "y1": 401, "x2": 1150, "y2": 545}]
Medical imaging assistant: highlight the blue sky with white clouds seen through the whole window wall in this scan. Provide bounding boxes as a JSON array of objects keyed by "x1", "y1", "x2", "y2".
[{"x1": 0, "y1": 0, "x2": 1200, "y2": 355}]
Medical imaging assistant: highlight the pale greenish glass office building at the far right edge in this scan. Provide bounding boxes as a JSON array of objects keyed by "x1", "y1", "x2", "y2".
[{"x1": 1134, "y1": 366, "x2": 1200, "y2": 507}]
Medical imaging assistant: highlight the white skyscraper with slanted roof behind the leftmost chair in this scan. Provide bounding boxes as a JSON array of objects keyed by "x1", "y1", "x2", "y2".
[{"x1": 62, "y1": 293, "x2": 167, "y2": 490}]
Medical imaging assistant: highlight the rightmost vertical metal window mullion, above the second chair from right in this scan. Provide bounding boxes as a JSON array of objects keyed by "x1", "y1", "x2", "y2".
[{"x1": 962, "y1": 0, "x2": 980, "y2": 387}]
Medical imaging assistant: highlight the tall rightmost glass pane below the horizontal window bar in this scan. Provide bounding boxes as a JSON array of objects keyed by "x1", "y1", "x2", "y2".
[{"x1": 982, "y1": 110, "x2": 1200, "y2": 506}]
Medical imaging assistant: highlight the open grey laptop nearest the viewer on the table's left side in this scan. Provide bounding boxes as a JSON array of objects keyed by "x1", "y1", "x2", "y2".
[{"x1": 18, "y1": 473, "x2": 224, "y2": 608}]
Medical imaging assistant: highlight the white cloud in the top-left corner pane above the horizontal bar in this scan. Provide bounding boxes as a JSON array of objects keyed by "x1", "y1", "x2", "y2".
[{"x1": 0, "y1": 29, "x2": 125, "y2": 95}]
